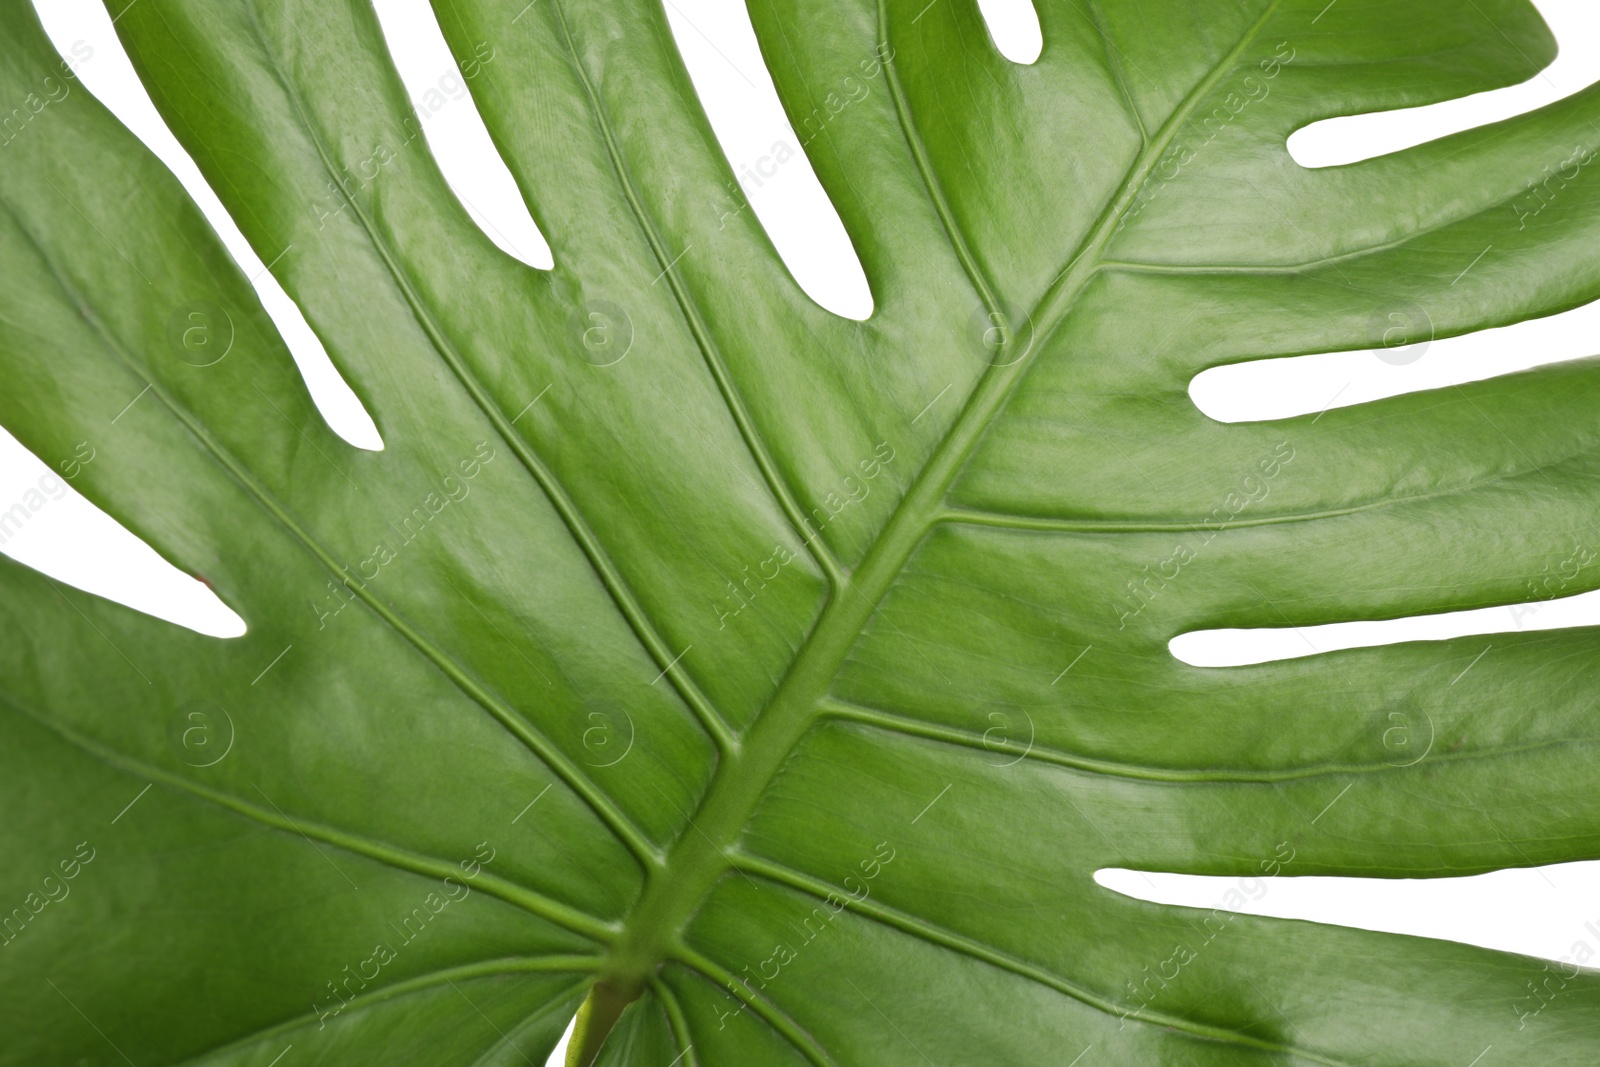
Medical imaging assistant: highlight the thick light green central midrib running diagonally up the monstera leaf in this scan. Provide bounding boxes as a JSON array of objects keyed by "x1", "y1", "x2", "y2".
[{"x1": 605, "y1": 0, "x2": 1282, "y2": 1025}]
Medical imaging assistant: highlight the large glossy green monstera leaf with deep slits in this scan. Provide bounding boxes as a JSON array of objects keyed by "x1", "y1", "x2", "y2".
[{"x1": 0, "y1": 0, "x2": 1600, "y2": 1067}]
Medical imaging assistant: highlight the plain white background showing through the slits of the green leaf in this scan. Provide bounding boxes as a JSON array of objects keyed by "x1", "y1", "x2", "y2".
[{"x1": 18, "y1": 0, "x2": 1600, "y2": 1062}]
